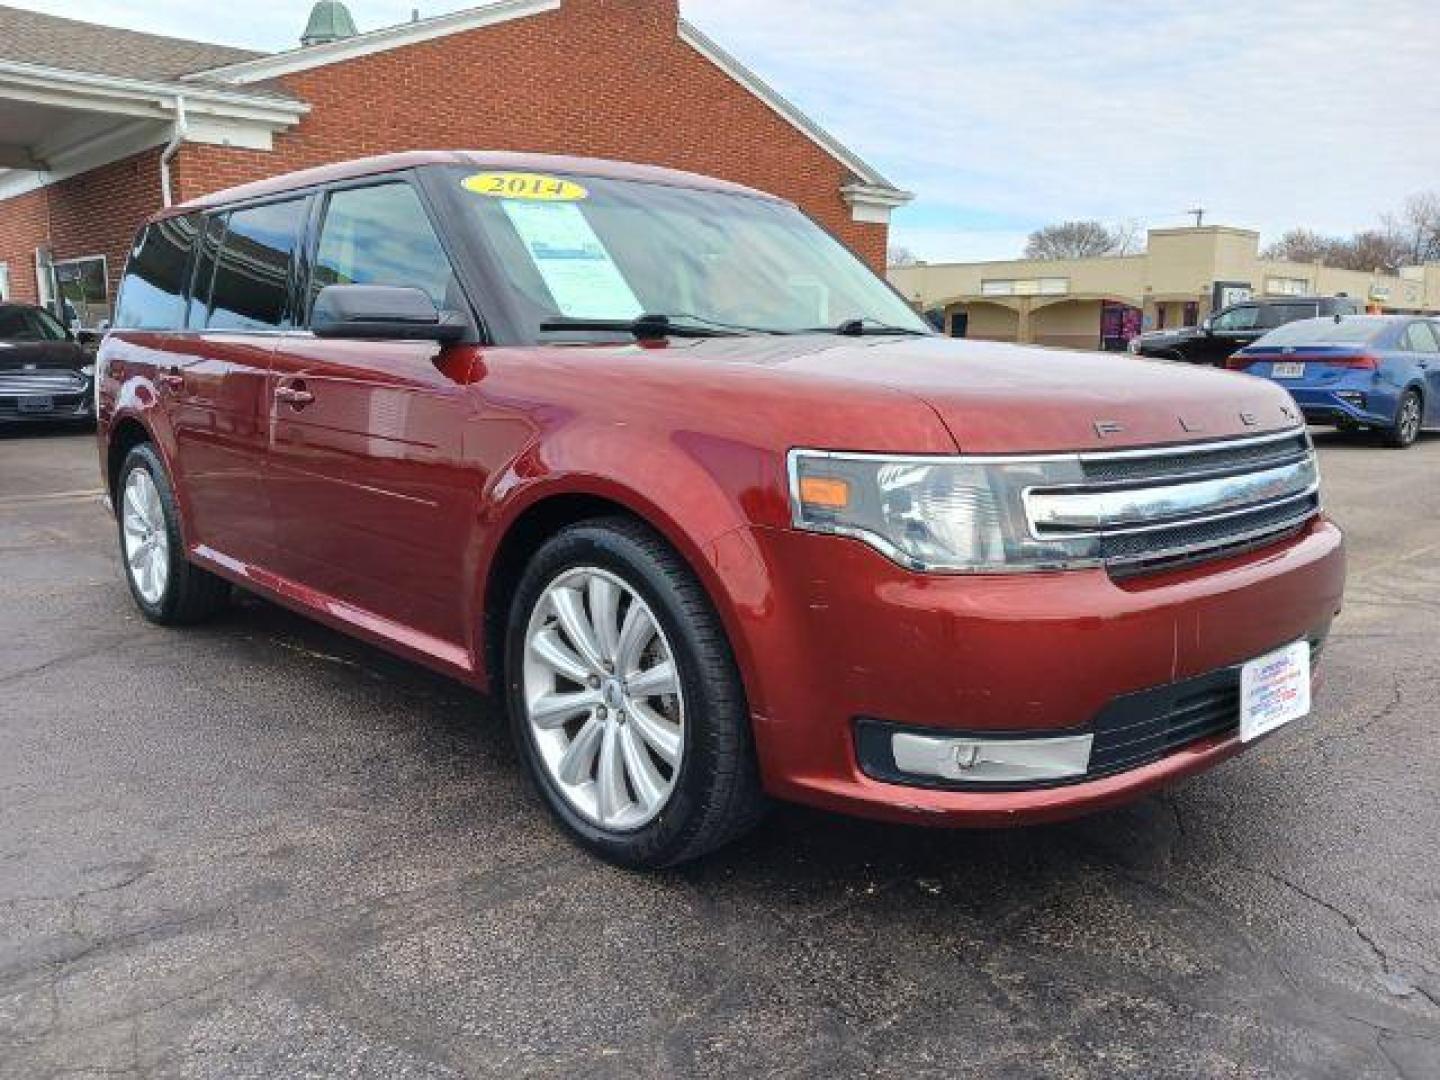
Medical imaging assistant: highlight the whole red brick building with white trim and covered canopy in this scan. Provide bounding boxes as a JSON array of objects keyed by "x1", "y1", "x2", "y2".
[{"x1": 0, "y1": 0, "x2": 910, "y2": 324}]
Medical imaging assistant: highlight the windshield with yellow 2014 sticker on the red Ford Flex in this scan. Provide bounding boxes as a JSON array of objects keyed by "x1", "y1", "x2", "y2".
[{"x1": 455, "y1": 170, "x2": 930, "y2": 337}]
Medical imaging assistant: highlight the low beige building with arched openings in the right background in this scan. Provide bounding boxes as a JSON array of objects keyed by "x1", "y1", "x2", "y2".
[{"x1": 890, "y1": 226, "x2": 1440, "y2": 348}]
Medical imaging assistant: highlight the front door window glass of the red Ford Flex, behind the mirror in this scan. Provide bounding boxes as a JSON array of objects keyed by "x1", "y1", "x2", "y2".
[{"x1": 310, "y1": 183, "x2": 458, "y2": 315}]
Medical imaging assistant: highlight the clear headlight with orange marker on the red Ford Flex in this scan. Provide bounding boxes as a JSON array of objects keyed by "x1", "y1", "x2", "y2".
[{"x1": 791, "y1": 449, "x2": 1100, "y2": 573}]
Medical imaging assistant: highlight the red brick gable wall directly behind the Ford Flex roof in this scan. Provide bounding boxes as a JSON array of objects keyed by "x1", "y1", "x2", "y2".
[{"x1": 177, "y1": 0, "x2": 888, "y2": 271}]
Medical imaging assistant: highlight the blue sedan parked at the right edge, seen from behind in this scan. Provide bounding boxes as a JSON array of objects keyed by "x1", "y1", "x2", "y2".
[{"x1": 1227, "y1": 315, "x2": 1440, "y2": 446}]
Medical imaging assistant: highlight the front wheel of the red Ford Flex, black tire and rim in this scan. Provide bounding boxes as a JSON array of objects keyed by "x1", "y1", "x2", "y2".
[{"x1": 505, "y1": 518, "x2": 766, "y2": 868}]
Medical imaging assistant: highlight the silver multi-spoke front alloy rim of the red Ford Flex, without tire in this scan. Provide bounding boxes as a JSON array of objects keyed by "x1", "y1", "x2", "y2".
[{"x1": 523, "y1": 567, "x2": 685, "y2": 832}]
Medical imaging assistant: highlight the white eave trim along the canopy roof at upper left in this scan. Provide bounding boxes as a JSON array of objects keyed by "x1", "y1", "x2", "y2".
[{"x1": 0, "y1": 60, "x2": 310, "y2": 131}]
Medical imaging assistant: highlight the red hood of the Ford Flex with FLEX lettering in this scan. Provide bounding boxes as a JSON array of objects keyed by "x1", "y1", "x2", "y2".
[{"x1": 672, "y1": 337, "x2": 1300, "y2": 454}]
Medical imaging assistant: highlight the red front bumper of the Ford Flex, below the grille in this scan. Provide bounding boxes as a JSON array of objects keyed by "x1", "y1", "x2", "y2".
[{"x1": 744, "y1": 520, "x2": 1345, "y2": 827}]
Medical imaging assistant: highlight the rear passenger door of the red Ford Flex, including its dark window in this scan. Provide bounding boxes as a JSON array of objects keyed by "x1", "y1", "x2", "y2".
[{"x1": 157, "y1": 197, "x2": 307, "y2": 566}]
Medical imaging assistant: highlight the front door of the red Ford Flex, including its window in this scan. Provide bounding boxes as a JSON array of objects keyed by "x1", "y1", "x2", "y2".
[{"x1": 266, "y1": 177, "x2": 480, "y2": 664}]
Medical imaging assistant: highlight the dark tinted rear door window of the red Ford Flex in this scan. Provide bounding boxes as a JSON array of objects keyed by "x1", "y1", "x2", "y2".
[{"x1": 206, "y1": 199, "x2": 305, "y2": 330}]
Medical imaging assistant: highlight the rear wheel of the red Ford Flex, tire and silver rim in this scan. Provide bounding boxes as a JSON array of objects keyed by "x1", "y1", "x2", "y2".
[{"x1": 115, "y1": 442, "x2": 230, "y2": 626}]
